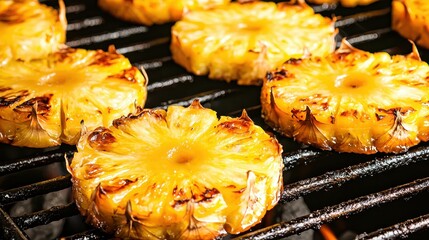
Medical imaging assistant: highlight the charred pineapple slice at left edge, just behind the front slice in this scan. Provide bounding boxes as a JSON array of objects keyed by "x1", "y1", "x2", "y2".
[{"x1": 0, "y1": 47, "x2": 147, "y2": 148}]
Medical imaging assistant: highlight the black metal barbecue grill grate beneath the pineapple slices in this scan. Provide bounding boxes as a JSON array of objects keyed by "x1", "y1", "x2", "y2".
[{"x1": 0, "y1": 0, "x2": 429, "y2": 240}]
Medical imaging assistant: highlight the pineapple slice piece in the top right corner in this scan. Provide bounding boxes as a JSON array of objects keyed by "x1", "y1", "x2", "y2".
[{"x1": 392, "y1": 0, "x2": 429, "y2": 49}]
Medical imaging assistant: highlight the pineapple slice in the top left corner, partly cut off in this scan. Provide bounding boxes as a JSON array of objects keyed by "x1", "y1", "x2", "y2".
[{"x1": 0, "y1": 0, "x2": 67, "y2": 63}]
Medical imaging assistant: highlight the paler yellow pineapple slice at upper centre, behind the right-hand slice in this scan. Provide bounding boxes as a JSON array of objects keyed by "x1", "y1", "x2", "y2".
[{"x1": 171, "y1": 1, "x2": 336, "y2": 85}]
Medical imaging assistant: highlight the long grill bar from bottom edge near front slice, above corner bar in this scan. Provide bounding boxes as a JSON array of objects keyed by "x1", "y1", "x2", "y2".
[{"x1": 235, "y1": 177, "x2": 429, "y2": 240}]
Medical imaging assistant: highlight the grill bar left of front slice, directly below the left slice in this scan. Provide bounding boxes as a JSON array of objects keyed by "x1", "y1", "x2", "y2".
[{"x1": 0, "y1": 149, "x2": 74, "y2": 175}]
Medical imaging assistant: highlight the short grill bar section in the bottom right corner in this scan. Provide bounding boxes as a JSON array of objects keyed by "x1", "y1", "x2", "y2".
[{"x1": 356, "y1": 214, "x2": 429, "y2": 240}]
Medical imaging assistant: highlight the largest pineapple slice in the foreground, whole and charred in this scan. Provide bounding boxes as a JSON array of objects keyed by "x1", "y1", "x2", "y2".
[{"x1": 68, "y1": 100, "x2": 283, "y2": 239}]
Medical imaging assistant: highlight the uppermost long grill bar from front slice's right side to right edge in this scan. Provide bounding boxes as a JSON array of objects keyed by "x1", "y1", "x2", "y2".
[{"x1": 281, "y1": 147, "x2": 429, "y2": 202}]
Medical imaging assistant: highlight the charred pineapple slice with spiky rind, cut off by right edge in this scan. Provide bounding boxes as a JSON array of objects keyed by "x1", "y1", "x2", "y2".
[{"x1": 261, "y1": 41, "x2": 429, "y2": 154}]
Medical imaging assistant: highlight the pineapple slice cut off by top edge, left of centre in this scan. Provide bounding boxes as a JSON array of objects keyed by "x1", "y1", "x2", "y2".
[{"x1": 98, "y1": 0, "x2": 230, "y2": 26}]
